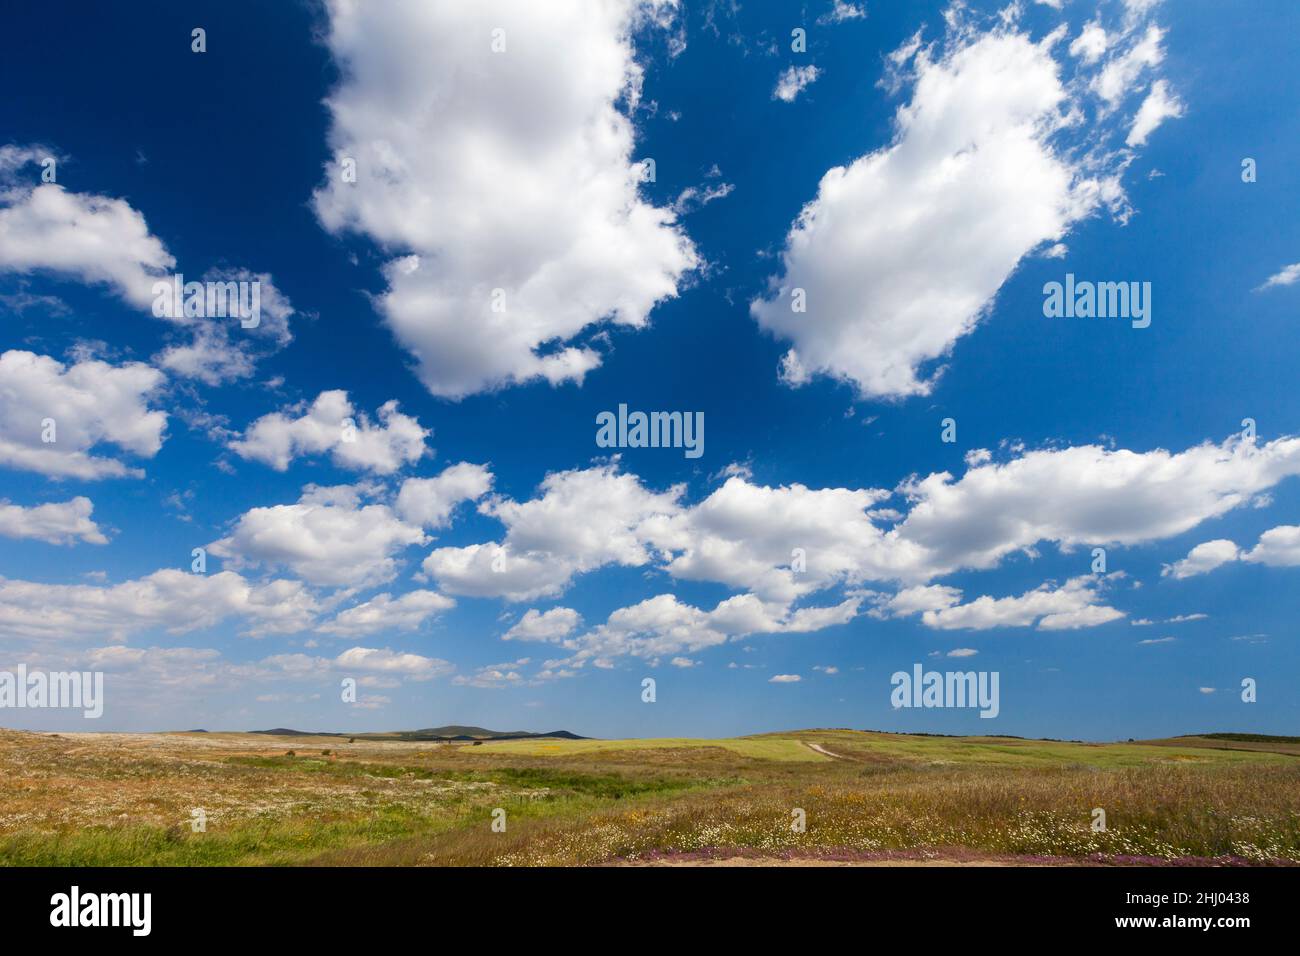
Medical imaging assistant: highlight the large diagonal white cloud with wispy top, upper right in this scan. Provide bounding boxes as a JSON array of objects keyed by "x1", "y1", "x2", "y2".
[{"x1": 750, "y1": 8, "x2": 1175, "y2": 397}]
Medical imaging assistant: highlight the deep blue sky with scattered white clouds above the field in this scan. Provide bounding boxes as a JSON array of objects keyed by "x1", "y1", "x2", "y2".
[{"x1": 0, "y1": 0, "x2": 1300, "y2": 739}]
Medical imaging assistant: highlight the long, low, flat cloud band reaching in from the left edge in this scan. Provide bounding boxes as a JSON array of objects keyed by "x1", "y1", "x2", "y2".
[{"x1": 0, "y1": 570, "x2": 317, "y2": 640}]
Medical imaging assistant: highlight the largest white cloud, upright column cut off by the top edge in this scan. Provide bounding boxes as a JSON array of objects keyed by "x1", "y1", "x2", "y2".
[{"x1": 315, "y1": 0, "x2": 697, "y2": 398}]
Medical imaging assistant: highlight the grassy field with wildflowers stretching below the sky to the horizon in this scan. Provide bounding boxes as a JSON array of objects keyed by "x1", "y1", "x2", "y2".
[{"x1": 0, "y1": 730, "x2": 1300, "y2": 865}]
